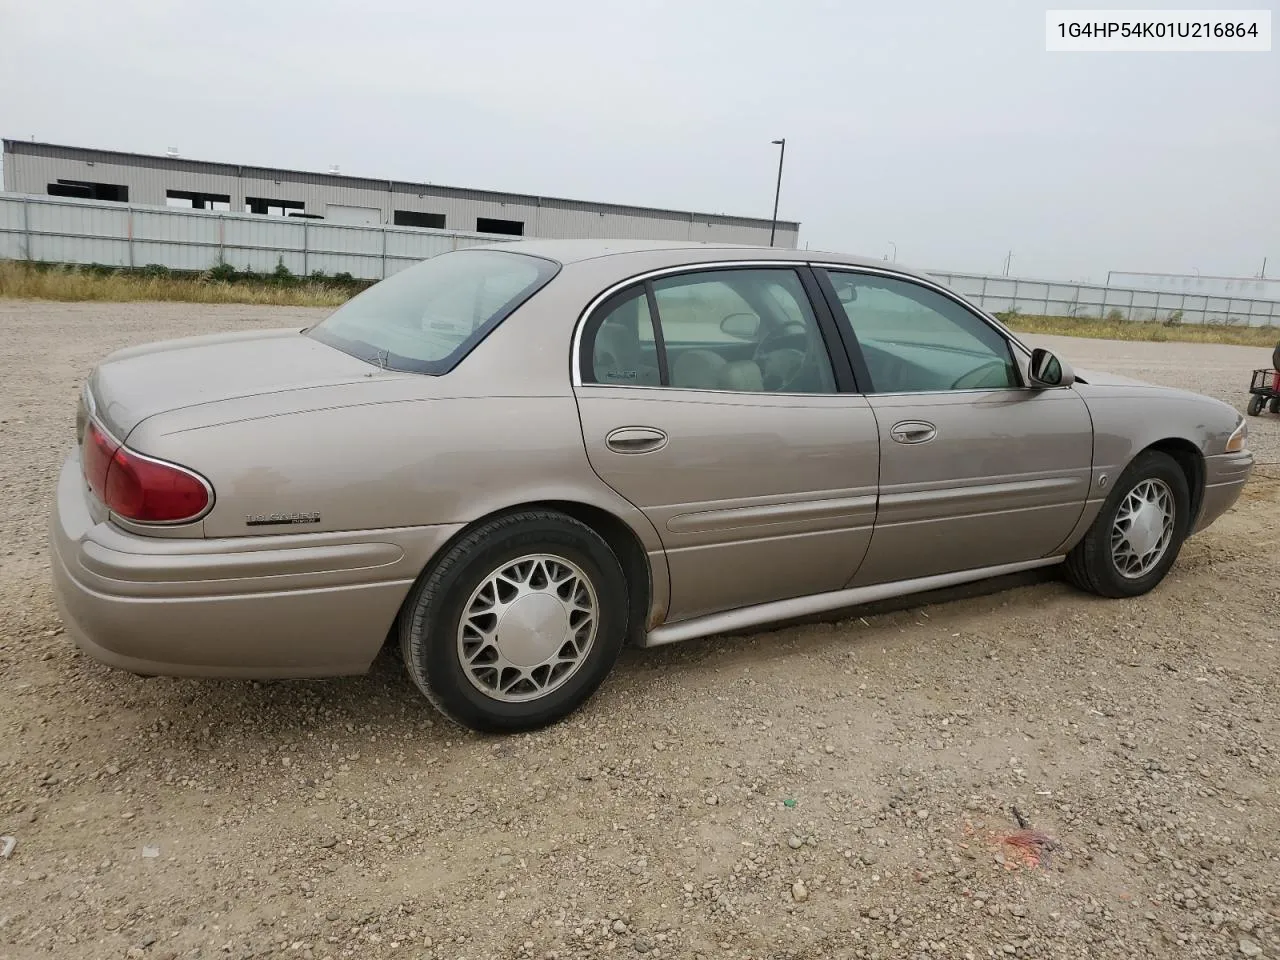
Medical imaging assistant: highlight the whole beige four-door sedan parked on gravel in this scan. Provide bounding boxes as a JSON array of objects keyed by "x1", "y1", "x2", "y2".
[{"x1": 51, "y1": 241, "x2": 1253, "y2": 730}]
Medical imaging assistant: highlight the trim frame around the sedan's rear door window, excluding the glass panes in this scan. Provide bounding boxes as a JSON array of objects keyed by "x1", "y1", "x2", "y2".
[{"x1": 570, "y1": 260, "x2": 859, "y2": 397}]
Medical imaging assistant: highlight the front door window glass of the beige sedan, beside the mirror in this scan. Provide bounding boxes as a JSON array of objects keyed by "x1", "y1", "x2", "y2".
[{"x1": 828, "y1": 270, "x2": 1020, "y2": 393}]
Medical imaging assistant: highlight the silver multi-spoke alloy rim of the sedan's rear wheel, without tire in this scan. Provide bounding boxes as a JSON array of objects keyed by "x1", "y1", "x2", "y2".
[{"x1": 457, "y1": 553, "x2": 599, "y2": 703}]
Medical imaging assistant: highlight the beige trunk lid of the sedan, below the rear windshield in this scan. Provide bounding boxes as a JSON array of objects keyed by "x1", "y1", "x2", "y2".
[{"x1": 88, "y1": 328, "x2": 384, "y2": 440}]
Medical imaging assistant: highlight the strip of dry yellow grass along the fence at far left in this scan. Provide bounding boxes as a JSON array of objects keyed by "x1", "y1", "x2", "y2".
[{"x1": 0, "y1": 261, "x2": 351, "y2": 307}]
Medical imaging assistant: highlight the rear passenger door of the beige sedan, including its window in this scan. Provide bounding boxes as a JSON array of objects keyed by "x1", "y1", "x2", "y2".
[{"x1": 575, "y1": 265, "x2": 879, "y2": 621}]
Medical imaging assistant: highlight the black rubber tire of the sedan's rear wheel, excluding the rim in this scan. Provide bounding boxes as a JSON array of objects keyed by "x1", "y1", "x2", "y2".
[{"x1": 399, "y1": 509, "x2": 628, "y2": 732}]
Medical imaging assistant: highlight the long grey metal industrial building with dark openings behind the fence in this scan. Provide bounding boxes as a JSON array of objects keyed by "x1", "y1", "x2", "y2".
[{"x1": 4, "y1": 140, "x2": 800, "y2": 248}]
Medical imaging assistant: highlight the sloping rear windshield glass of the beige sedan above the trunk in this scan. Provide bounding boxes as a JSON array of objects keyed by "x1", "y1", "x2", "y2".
[{"x1": 310, "y1": 250, "x2": 559, "y2": 374}]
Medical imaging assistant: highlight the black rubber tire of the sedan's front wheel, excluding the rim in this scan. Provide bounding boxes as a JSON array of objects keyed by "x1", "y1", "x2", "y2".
[{"x1": 1065, "y1": 451, "x2": 1192, "y2": 596}]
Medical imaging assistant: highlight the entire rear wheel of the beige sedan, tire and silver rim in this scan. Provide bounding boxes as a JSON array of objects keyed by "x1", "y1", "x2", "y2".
[{"x1": 401, "y1": 511, "x2": 627, "y2": 731}]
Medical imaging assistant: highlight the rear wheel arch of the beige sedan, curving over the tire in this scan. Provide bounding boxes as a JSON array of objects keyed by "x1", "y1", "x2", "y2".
[{"x1": 390, "y1": 499, "x2": 666, "y2": 646}]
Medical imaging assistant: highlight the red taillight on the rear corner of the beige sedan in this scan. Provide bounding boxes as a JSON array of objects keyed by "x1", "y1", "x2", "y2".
[{"x1": 81, "y1": 421, "x2": 212, "y2": 524}]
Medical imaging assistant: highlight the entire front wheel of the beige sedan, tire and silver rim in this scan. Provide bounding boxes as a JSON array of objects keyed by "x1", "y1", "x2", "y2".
[{"x1": 1066, "y1": 451, "x2": 1190, "y2": 596}]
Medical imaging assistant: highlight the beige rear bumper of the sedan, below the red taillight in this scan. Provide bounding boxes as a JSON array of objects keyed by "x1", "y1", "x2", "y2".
[{"x1": 50, "y1": 453, "x2": 458, "y2": 678}]
